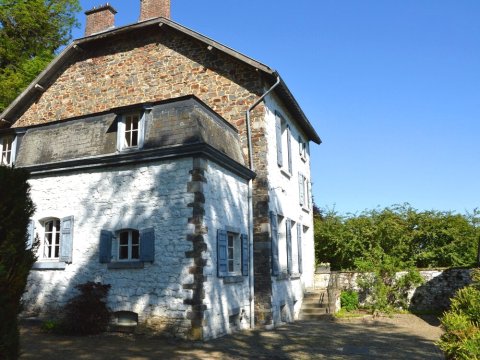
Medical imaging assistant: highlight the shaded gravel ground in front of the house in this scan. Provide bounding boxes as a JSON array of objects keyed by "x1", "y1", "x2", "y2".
[{"x1": 21, "y1": 314, "x2": 443, "y2": 360}]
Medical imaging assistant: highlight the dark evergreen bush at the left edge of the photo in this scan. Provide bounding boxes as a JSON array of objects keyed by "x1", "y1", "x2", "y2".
[{"x1": 0, "y1": 166, "x2": 35, "y2": 359}]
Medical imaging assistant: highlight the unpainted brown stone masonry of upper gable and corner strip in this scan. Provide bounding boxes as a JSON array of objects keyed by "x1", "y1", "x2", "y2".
[{"x1": 14, "y1": 26, "x2": 282, "y2": 330}]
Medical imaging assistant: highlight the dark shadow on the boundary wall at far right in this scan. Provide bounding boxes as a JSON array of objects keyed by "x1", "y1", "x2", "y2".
[{"x1": 409, "y1": 269, "x2": 471, "y2": 313}]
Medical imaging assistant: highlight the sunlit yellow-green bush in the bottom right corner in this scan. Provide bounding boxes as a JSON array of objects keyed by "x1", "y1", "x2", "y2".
[{"x1": 438, "y1": 269, "x2": 480, "y2": 359}]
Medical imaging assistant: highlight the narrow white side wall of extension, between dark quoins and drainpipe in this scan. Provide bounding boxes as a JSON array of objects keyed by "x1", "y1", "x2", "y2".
[{"x1": 203, "y1": 161, "x2": 251, "y2": 339}]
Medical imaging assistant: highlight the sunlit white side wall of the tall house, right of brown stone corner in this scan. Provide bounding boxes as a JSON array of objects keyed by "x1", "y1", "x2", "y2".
[{"x1": 262, "y1": 95, "x2": 315, "y2": 323}]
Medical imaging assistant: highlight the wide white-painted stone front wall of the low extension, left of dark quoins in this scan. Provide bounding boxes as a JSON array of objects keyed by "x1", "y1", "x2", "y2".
[{"x1": 24, "y1": 158, "x2": 193, "y2": 331}]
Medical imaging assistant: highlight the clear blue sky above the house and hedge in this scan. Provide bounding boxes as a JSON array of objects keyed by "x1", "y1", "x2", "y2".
[{"x1": 73, "y1": 0, "x2": 480, "y2": 213}]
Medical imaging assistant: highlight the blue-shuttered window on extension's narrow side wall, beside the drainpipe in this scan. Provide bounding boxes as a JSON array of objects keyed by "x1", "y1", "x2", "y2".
[{"x1": 217, "y1": 230, "x2": 249, "y2": 277}]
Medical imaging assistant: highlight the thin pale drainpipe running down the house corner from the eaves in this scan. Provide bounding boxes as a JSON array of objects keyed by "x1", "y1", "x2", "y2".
[{"x1": 245, "y1": 75, "x2": 281, "y2": 329}]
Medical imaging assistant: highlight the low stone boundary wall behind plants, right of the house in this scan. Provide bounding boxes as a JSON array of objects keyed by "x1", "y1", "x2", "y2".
[{"x1": 315, "y1": 269, "x2": 471, "y2": 312}]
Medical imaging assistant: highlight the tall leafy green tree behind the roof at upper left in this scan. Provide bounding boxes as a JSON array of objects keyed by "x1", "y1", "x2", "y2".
[{"x1": 0, "y1": 0, "x2": 80, "y2": 112}]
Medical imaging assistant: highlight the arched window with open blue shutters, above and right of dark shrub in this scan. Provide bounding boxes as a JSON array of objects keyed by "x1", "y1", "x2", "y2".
[{"x1": 99, "y1": 228, "x2": 155, "y2": 269}]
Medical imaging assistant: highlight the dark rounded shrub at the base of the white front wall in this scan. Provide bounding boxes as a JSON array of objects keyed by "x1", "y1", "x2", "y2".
[{"x1": 62, "y1": 281, "x2": 111, "y2": 335}]
